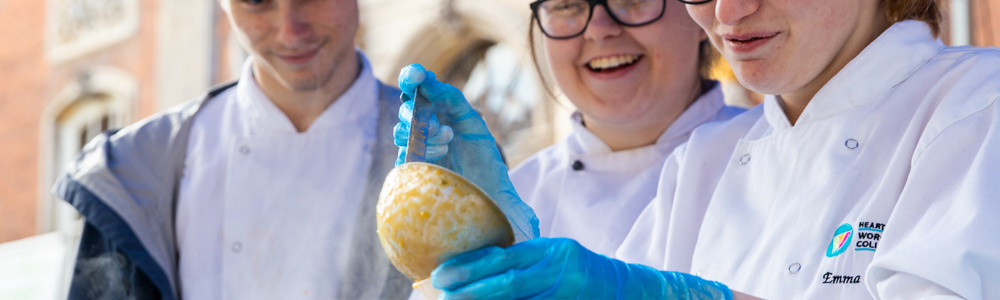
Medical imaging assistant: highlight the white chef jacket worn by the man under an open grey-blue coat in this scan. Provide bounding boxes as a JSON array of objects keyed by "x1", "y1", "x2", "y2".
[{"x1": 176, "y1": 52, "x2": 378, "y2": 299}]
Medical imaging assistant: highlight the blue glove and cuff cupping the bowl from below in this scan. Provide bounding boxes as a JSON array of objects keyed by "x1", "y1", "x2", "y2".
[{"x1": 431, "y1": 238, "x2": 733, "y2": 300}]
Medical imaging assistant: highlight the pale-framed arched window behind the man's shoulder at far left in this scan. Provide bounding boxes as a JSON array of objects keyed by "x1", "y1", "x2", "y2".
[{"x1": 28, "y1": 67, "x2": 138, "y2": 298}]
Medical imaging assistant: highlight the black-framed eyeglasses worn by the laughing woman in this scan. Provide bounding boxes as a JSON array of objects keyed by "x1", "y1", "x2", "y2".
[{"x1": 530, "y1": 0, "x2": 712, "y2": 40}]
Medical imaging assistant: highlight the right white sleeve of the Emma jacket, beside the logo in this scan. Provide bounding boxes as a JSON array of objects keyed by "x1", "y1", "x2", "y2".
[{"x1": 865, "y1": 98, "x2": 1000, "y2": 299}]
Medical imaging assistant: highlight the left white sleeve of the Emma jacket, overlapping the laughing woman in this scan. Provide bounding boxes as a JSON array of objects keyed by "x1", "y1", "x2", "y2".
[{"x1": 615, "y1": 143, "x2": 687, "y2": 269}]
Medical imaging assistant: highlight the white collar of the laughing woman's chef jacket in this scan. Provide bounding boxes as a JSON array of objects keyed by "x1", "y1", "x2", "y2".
[{"x1": 570, "y1": 83, "x2": 726, "y2": 155}]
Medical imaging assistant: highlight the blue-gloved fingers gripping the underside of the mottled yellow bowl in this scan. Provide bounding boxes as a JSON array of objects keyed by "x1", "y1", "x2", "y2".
[{"x1": 431, "y1": 239, "x2": 549, "y2": 289}]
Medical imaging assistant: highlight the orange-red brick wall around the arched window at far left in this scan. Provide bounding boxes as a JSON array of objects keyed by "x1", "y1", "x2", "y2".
[{"x1": 0, "y1": 1, "x2": 166, "y2": 242}]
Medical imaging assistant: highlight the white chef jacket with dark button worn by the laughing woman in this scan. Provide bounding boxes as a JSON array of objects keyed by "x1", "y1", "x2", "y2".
[{"x1": 510, "y1": 84, "x2": 743, "y2": 257}]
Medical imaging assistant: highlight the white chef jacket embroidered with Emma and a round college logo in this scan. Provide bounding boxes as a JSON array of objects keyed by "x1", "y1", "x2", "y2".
[{"x1": 618, "y1": 21, "x2": 1000, "y2": 299}]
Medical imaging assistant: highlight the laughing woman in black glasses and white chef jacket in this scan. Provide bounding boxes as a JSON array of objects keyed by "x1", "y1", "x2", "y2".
[{"x1": 397, "y1": 0, "x2": 743, "y2": 264}]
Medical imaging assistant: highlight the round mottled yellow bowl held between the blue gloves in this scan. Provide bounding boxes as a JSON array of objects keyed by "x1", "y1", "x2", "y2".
[{"x1": 376, "y1": 163, "x2": 514, "y2": 281}]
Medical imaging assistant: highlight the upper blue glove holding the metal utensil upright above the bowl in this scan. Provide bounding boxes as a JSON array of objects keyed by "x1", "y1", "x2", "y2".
[{"x1": 393, "y1": 64, "x2": 538, "y2": 242}]
